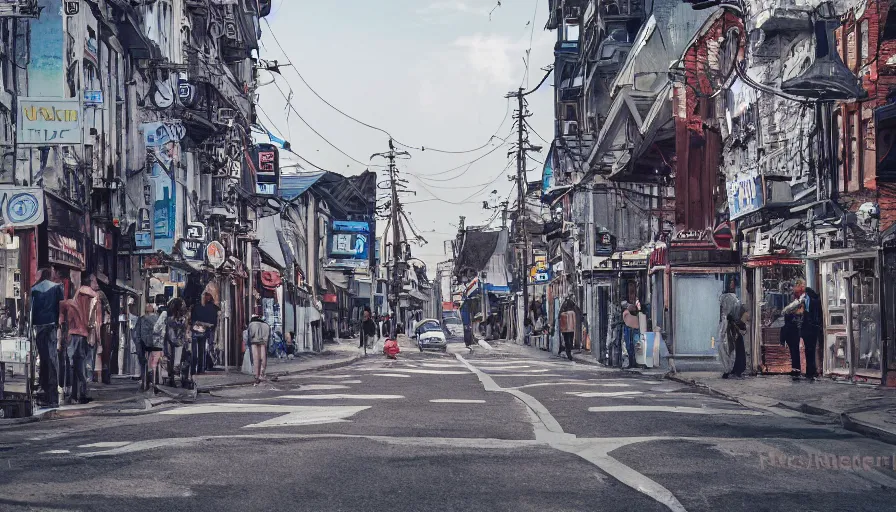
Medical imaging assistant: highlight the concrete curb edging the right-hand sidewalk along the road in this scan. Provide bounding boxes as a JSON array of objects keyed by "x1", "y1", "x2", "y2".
[{"x1": 666, "y1": 374, "x2": 896, "y2": 445}]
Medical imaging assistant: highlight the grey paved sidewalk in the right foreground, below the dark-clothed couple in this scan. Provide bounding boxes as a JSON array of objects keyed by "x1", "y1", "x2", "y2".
[{"x1": 668, "y1": 372, "x2": 896, "y2": 444}]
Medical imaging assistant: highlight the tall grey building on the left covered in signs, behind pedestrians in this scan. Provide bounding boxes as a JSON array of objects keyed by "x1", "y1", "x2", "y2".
[{"x1": 0, "y1": 0, "x2": 319, "y2": 378}]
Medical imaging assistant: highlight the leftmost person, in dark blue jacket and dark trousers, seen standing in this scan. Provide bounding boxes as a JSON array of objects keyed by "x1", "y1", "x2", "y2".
[{"x1": 30, "y1": 268, "x2": 65, "y2": 407}]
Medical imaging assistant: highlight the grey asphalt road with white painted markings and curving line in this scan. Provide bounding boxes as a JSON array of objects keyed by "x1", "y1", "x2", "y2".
[{"x1": 0, "y1": 344, "x2": 896, "y2": 512}]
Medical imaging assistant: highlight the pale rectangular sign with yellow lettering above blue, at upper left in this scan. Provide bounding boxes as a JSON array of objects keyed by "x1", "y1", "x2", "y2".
[{"x1": 18, "y1": 98, "x2": 82, "y2": 144}]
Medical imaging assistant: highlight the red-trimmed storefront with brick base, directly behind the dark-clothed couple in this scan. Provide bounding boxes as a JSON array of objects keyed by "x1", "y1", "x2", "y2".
[{"x1": 743, "y1": 256, "x2": 806, "y2": 374}]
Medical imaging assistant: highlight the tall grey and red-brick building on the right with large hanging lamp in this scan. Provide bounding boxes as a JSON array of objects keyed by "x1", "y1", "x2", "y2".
[{"x1": 543, "y1": 0, "x2": 896, "y2": 380}]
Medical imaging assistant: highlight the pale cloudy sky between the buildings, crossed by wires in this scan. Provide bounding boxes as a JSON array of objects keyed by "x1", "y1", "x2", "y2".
[{"x1": 259, "y1": 0, "x2": 556, "y2": 276}]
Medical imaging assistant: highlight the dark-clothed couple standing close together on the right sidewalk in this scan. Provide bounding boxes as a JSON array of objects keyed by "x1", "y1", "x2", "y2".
[{"x1": 781, "y1": 279, "x2": 824, "y2": 382}]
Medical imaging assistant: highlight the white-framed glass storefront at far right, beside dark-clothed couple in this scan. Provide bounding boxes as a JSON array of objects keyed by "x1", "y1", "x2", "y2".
[{"x1": 818, "y1": 252, "x2": 884, "y2": 382}]
